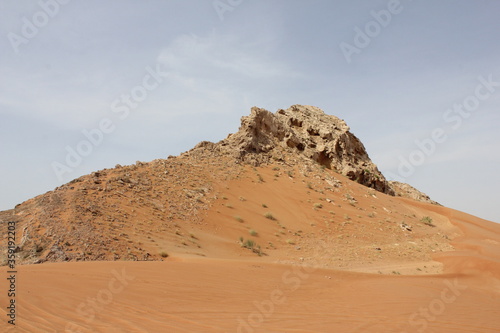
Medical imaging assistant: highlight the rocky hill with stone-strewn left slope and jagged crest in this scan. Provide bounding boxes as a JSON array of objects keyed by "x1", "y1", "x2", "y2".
[{"x1": 0, "y1": 105, "x2": 440, "y2": 263}]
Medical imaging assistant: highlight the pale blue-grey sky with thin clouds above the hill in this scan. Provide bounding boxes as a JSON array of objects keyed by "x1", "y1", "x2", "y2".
[{"x1": 0, "y1": 0, "x2": 500, "y2": 222}]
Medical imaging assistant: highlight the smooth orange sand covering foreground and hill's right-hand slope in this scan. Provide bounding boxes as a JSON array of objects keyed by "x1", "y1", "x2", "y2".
[{"x1": 0, "y1": 167, "x2": 500, "y2": 332}]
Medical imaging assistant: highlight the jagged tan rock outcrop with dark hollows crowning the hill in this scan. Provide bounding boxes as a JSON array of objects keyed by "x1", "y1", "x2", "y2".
[{"x1": 209, "y1": 105, "x2": 394, "y2": 195}]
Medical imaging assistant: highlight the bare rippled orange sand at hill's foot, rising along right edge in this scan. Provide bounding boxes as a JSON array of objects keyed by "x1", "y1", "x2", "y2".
[{"x1": 0, "y1": 188, "x2": 500, "y2": 332}]
